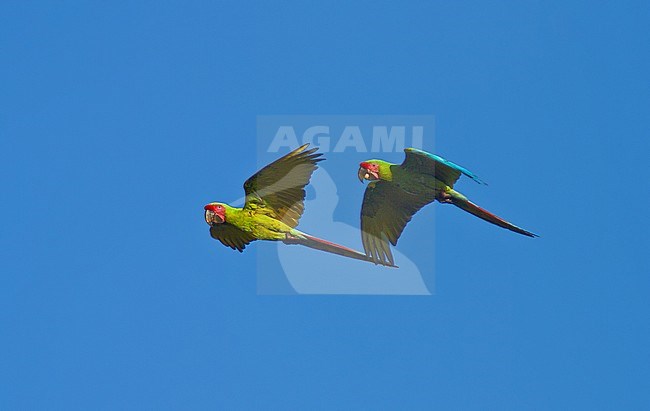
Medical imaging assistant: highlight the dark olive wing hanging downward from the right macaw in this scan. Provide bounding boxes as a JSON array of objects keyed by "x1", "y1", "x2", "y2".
[{"x1": 361, "y1": 181, "x2": 435, "y2": 265}]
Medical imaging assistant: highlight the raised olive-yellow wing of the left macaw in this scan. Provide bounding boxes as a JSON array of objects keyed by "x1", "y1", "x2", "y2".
[{"x1": 244, "y1": 144, "x2": 323, "y2": 227}]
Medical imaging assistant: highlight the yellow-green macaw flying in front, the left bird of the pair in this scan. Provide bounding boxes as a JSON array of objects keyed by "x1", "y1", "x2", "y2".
[{"x1": 204, "y1": 144, "x2": 394, "y2": 266}]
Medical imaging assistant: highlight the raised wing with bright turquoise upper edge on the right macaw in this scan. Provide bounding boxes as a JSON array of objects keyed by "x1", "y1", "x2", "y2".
[{"x1": 401, "y1": 148, "x2": 485, "y2": 187}]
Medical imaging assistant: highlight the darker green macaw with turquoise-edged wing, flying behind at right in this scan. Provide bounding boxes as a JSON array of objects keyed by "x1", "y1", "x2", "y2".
[{"x1": 358, "y1": 148, "x2": 537, "y2": 264}]
